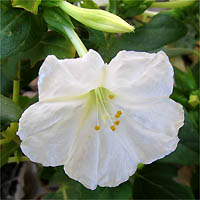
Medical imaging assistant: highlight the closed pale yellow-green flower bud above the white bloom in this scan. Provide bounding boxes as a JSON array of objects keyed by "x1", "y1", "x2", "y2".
[{"x1": 58, "y1": 1, "x2": 134, "y2": 33}]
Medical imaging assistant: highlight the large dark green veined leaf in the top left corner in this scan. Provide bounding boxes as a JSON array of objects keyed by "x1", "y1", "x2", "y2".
[{"x1": 0, "y1": 1, "x2": 46, "y2": 59}]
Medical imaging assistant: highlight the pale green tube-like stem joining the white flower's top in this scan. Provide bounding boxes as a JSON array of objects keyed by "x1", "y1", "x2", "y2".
[{"x1": 64, "y1": 26, "x2": 88, "y2": 57}]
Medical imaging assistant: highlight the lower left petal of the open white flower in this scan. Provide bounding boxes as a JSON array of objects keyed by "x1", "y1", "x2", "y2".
[{"x1": 18, "y1": 101, "x2": 84, "y2": 166}]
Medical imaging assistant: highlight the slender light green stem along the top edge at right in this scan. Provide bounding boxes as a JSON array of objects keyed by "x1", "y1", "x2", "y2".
[{"x1": 150, "y1": 0, "x2": 196, "y2": 8}]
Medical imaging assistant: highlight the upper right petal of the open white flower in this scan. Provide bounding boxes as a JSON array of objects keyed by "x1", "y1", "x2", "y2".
[{"x1": 105, "y1": 51, "x2": 173, "y2": 101}]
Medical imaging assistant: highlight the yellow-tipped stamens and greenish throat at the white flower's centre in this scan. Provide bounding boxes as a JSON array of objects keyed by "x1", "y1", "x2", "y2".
[{"x1": 93, "y1": 87, "x2": 122, "y2": 131}]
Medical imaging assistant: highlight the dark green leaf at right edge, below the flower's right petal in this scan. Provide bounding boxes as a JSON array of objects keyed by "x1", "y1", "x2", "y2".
[{"x1": 159, "y1": 111, "x2": 199, "y2": 165}]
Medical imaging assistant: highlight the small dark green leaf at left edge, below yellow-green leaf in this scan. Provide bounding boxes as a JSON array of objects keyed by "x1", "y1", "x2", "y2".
[{"x1": 0, "y1": 142, "x2": 19, "y2": 167}]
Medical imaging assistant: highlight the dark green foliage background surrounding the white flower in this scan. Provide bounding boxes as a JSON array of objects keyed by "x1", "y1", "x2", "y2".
[{"x1": 0, "y1": 0, "x2": 200, "y2": 199}]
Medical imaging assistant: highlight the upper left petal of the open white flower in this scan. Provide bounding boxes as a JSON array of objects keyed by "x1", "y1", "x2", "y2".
[{"x1": 38, "y1": 50, "x2": 104, "y2": 101}]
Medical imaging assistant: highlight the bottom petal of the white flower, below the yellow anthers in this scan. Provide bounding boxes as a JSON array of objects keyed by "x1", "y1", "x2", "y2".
[{"x1": 64, "y1": 109, "x2": 139, "y2": 190}]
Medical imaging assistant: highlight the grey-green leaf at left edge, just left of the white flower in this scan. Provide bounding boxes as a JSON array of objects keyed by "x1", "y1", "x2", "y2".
[{"x1": 0, "y1": 95, "x2": 22, "y2": 130}]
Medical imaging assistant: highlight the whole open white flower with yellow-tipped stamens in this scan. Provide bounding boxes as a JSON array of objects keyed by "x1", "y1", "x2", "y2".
[{"x1": 18, "y1": 50, "x2": 184, "y2": 190}]
